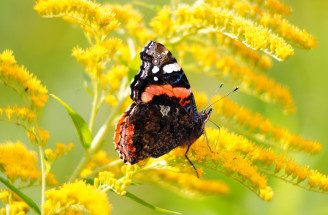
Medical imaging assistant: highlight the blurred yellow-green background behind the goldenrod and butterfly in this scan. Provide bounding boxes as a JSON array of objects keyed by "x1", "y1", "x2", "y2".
[{"x1": 0, "y1": 0, "x2": 328, "y2": 215}]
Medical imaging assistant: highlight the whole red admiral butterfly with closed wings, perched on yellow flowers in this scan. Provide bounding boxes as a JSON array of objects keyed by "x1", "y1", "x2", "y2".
[{"x1": 114, "y1": 41, "x2": 212, "y2": 175}]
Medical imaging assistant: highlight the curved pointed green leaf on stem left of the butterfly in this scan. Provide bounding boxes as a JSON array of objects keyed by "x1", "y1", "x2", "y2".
[{"x1": 50, "y1": 94, "x2": 92, "y2": 149}]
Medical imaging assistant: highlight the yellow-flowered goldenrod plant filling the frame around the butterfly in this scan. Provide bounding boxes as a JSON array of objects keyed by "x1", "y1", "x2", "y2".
[{"x1": 0, "y1": 0, "x2": 328, "y2": 215}]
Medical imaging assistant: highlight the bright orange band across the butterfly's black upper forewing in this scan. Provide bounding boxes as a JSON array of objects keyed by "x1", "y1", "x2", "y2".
[{"x1": 141, "y1": 84, "x2": 191, "y2": 106}]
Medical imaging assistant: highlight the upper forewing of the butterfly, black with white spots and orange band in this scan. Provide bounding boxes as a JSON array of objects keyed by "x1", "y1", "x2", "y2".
[{"x1": 130, "y1": 41, "x2": 197, "y2": 120}]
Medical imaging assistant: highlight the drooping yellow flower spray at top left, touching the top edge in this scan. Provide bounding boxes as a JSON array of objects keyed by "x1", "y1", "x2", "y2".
[{"x1": 34, "y1": 0, "x2": 119, "y2": 39}]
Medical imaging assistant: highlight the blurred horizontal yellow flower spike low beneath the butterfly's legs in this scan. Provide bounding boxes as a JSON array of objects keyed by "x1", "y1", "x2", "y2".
[{"x1": 135, "y1": 170, "x2": 229, "y2": 197}]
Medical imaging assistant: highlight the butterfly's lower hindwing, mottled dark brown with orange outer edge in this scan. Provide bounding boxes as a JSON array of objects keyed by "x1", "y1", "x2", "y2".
[{"x1": 114, "y1": 103, "x2": 194, "y2": 164}]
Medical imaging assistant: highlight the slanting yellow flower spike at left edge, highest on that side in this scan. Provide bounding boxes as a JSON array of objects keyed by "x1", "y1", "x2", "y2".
[{"x1": 0, "y1": 50, "x2": 48, "y2": 111}]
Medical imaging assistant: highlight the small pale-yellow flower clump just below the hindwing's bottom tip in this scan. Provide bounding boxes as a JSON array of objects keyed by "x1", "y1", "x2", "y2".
[{"x1": 94, "y1": 165, "x2": 138, "y2": 196}]
